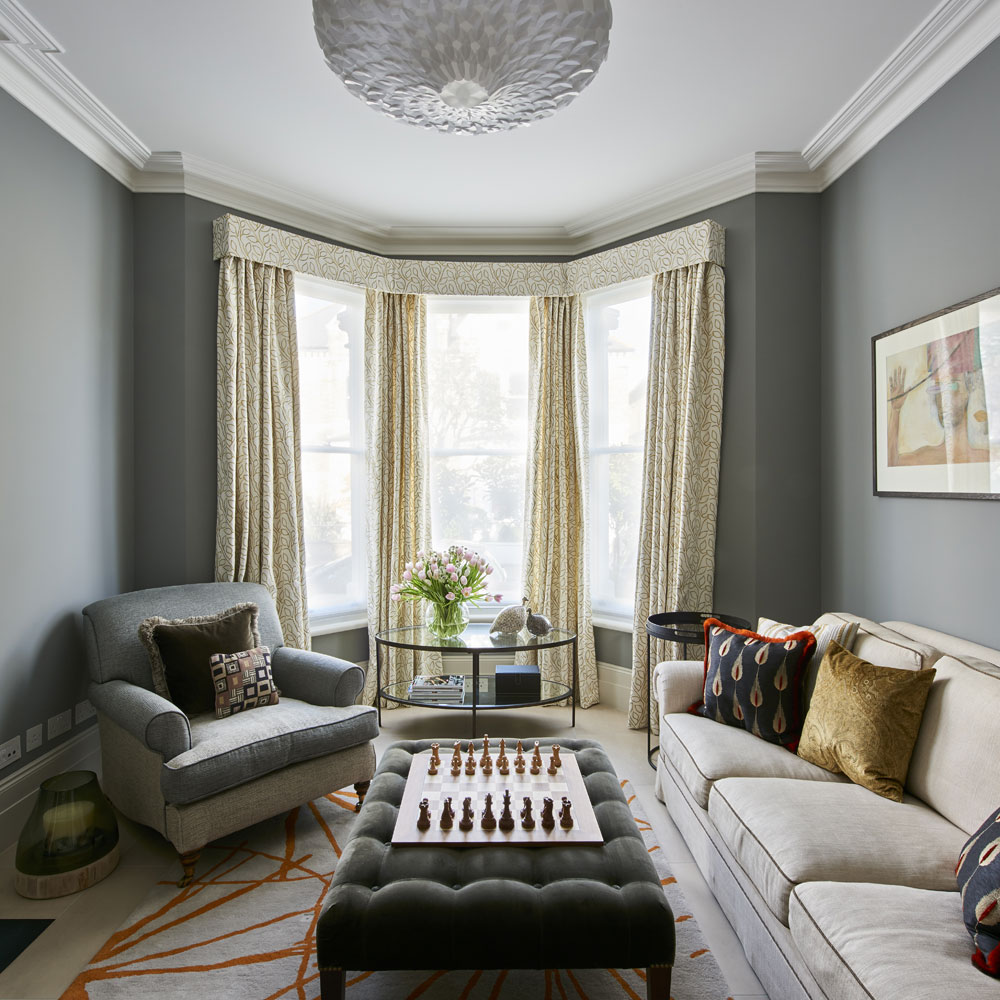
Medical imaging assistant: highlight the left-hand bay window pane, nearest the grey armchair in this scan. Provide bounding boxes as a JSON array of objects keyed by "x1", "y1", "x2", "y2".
[{"x1": 295, "y1": 275, "x2": 365, "y2": 615}]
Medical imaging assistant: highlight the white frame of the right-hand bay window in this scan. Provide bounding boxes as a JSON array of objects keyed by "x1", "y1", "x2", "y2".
[{"x1": 584, "y1": 277, "x2": 653, "y2": 632}]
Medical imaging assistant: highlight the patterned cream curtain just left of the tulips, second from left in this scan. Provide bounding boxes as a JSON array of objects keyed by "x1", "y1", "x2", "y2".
[{"x1": 364, "y1": 289, "x2": 441, "y2": 708}]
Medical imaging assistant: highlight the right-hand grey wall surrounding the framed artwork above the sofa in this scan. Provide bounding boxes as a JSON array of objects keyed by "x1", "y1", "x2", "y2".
[{"x1": 821, "y1": 35, "x2": 1000, "y2": 646}]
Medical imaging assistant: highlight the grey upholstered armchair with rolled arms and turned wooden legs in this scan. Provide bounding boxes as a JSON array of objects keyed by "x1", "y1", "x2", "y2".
[{"x1": 83, "y1": 583, "x2": 378, "y2": 885}]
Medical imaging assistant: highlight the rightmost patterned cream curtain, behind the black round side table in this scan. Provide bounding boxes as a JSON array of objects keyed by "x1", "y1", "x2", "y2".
[{"x1": 628, "y1": 262, "x2": 725, "y2": 729}]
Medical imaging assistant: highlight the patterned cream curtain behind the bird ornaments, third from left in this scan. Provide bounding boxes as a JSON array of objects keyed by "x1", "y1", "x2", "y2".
[{"x1": 524, "y1": 295, "x2": 598, "y2": 708}]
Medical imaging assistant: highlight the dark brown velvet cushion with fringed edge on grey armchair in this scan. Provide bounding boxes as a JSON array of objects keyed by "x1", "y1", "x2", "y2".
[{"x1": 139, "y1": 603, "x2": 260, "y2": 715}]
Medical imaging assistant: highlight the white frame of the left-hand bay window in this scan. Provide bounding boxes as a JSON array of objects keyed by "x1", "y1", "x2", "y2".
[{"x1": 295, "y1": 273, "x2": 368, "y2": 635}]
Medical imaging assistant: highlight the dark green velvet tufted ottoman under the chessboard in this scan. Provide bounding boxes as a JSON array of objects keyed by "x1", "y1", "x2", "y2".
[{"x1": 316, "y1": 740, "x2": 674, "y2": 1000}]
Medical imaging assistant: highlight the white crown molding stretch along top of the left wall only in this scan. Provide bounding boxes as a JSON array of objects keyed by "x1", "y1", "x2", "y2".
[{"x1": 0, "y1": 0, "x2": 149, "y2": 186}]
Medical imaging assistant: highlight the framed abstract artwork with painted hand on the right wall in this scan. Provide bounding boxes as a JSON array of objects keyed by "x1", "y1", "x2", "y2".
[{"x1": 872, "y1": 288, "x2": 1000, "y2": 500}]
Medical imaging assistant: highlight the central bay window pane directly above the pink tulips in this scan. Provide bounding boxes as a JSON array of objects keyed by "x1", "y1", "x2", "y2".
[{"x1": 427, "y1": 297, "x2": 528, "y2": 600}]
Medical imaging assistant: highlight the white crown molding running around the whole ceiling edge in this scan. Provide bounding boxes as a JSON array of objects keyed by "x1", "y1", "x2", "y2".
[{"x1": 0, "y1": 0, "x2": 1000, "y2": 256}]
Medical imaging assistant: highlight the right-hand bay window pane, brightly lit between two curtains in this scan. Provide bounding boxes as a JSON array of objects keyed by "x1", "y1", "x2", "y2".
[{"x1": 584, "y1": 278, "x2": 652, "y2": 628}]
